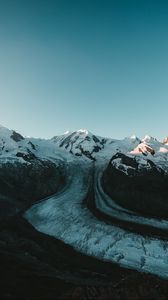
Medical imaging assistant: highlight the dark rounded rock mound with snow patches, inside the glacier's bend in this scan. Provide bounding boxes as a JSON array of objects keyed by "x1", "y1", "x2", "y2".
[{"x1": 102, "y1": 153, "x2": 168, "y2": 218}]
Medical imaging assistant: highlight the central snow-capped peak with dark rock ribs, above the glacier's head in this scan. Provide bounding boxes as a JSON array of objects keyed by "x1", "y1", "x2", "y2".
[{"x1": 52, "y1": 129, "x2": 141, "y2": 160}]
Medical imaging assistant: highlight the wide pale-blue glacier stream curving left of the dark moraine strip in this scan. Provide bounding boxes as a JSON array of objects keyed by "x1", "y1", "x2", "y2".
[{"x1": 24, "y1": 160, "x2": 168, "y2": 278}]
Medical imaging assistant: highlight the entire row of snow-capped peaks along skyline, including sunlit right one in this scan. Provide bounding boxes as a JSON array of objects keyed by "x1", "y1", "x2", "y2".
[{"x1": 0, "y1": 126, "x2": 168, "y2": 163}]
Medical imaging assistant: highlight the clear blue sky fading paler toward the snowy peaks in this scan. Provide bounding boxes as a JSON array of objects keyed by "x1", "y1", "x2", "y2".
[{"x1": 0, "y1": 0, "x2": 168, "y2": 138}]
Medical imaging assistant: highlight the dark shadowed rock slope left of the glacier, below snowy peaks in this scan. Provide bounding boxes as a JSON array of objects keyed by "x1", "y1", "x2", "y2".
[{"x1": 0, "y1": 159, "x2": 64, "y2": 217}]
